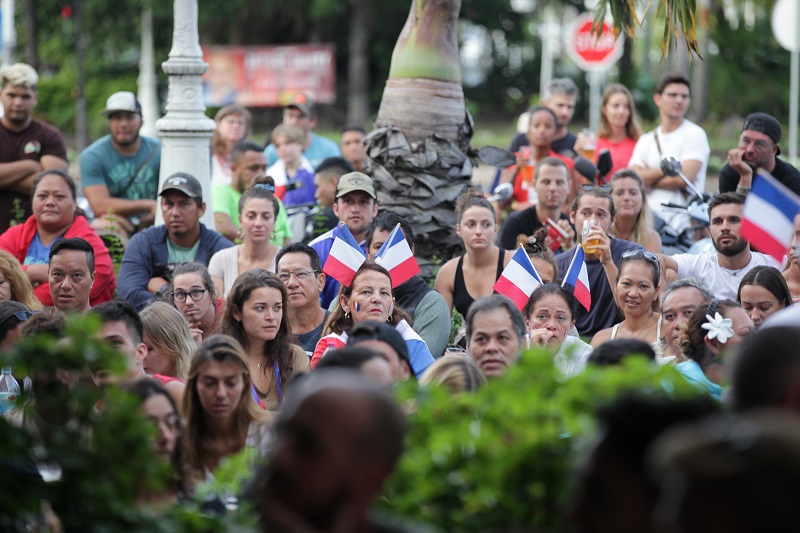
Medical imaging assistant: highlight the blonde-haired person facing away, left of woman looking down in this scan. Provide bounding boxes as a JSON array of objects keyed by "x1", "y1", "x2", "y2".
[{"x1": 139, "y1": 302, "x2": 196, "y2": 381}]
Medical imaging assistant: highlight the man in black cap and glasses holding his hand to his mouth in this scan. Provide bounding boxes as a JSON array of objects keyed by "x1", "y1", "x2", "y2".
[{"x1": 719, "y1": 113, "x2": 800, "y2": 194}]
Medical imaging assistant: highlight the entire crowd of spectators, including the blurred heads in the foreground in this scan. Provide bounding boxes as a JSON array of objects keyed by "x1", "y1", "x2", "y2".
[{"x1": 0, "y1": 59, "x2": 800, "y2": 531}]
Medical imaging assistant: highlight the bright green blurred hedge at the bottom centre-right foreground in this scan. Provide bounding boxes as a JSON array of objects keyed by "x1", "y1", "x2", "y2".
[{"x1": 383, "y1": 351, "x2": 697, "y2": 531}]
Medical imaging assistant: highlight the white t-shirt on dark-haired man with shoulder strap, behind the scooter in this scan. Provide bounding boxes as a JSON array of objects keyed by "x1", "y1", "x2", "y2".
[{"x1": 628, "y1": 120, "x2": 711, "y2": 230}]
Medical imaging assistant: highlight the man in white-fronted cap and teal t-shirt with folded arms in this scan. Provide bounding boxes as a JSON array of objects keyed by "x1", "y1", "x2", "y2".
[{"x1": 80, "y1": 91, "x2": 161, "y2": 240}]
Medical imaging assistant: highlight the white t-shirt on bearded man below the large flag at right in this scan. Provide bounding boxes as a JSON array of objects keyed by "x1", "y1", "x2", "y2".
[{"x1": 672, "y1": 252, "x2": 780, "y2": 301}]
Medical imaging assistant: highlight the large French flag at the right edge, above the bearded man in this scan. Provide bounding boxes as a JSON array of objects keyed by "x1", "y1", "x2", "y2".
[{"x1": 742, "y1": 168, "x2": 800, "y2": 262}]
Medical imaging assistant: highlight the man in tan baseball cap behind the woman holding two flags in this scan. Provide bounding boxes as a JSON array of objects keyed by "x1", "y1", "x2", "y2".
[{"x1": 309, "y1": 172, "x2": 378, "y2": 309}]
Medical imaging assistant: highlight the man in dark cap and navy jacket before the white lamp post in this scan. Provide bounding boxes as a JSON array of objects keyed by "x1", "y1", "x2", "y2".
[{"x1": 117, "y1": 172, "x2": 233, "y2": 310}]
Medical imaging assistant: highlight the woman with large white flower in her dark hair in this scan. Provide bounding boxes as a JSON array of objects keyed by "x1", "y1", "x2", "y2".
[{"x1": 675, "y1": 298, "x2": 756, "y2": 400}]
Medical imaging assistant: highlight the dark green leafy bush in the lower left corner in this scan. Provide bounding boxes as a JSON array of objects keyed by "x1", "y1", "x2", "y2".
[{"x1": 0, "y1": 317, "x2": 247, "y2": 533}]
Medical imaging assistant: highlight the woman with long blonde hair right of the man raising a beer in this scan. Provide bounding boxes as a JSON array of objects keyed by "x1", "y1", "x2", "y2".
[{"x1": 609, "y1": 169, "x2": 661, "y2": 254}]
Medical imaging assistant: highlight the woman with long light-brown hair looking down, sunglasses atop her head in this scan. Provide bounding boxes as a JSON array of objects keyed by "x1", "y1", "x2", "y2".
[{"x1": 181, "y1": 335, "x2": 268, "y2": 481}]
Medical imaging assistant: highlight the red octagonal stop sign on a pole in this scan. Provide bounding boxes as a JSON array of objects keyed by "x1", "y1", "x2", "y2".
[{"x1": 567, "y1": 15, "x2": 622, "y2": 70}]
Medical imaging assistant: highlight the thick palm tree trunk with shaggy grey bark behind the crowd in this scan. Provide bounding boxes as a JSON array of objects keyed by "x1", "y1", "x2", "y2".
[{"x1": 367, "y1": 0, "x2": 473, "y2": 277}]
